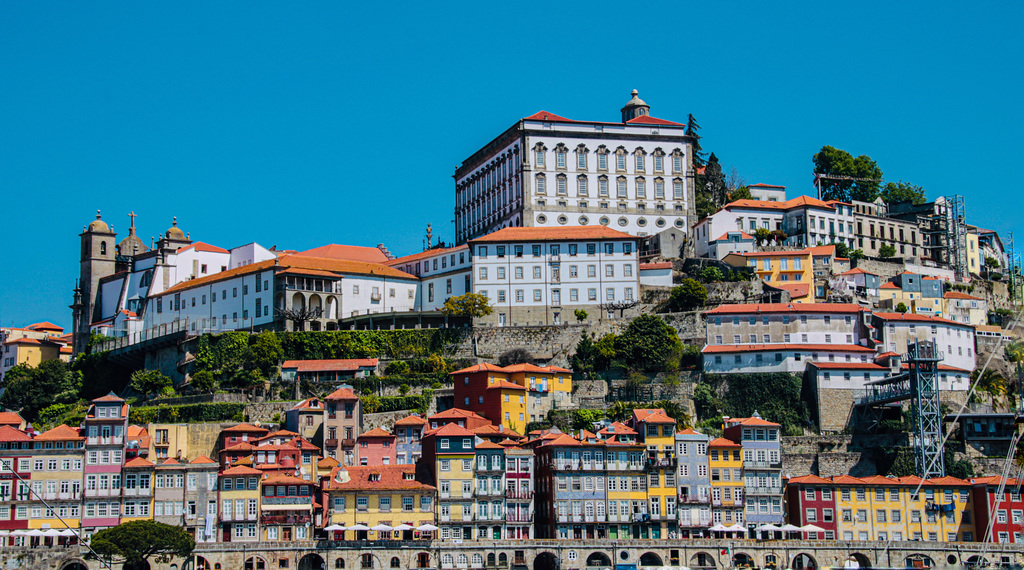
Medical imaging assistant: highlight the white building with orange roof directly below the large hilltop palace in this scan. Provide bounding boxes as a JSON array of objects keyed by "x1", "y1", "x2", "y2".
[{"x1": 469, "y1": 226, "x2": 640, "y2": 325}]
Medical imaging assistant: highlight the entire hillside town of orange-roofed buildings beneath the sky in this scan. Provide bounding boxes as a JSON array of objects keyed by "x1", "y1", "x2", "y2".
[{"x1": 0, "y1": 90, "x2": 1024, "y2": 570}]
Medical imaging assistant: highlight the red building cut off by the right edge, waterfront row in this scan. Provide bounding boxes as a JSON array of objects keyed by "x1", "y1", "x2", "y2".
[{"x1": 971, "y1": 477, "x2": 1024, "y2": 544}]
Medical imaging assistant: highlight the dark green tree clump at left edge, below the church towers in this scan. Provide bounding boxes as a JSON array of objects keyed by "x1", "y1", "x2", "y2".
[{"x1": 0, "y1": 360, "x2": 82, "y2": 422}]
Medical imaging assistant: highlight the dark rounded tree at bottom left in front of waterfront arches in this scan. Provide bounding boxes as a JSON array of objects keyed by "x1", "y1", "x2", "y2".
[{"x1": 90, "y1": 521, "x2": 196, "y2": 568}]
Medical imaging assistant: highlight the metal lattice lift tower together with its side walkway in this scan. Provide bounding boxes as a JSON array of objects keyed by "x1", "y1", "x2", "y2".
[{"x1": 853, "y1": 341, "x2": 946, "y2": 479}]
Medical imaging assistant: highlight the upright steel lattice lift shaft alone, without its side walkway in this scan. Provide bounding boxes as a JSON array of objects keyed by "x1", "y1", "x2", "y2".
[{"x1": 905, "y1": 341, "x2": 946, "y2": 479}]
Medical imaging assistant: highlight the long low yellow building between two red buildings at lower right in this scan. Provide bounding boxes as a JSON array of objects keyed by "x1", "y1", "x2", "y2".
[{"x1": 831, "y1": 476, "x2": 978, "y2": 542}]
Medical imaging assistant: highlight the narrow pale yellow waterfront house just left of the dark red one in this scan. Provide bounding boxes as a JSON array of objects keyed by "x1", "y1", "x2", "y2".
[{"x1": 218, "y1": 459, "x2": 263, "y2": 542}]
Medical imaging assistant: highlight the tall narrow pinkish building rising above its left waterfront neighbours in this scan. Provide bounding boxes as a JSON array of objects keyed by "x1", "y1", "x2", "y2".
[{"x1": 82, "y1": 393, "x2": 128, "y2": 535}]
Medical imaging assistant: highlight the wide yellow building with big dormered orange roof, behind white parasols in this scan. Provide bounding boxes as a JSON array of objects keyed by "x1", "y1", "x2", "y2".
[{"x1": 324, "y1": 465, "x2": 436, "y2": 540}]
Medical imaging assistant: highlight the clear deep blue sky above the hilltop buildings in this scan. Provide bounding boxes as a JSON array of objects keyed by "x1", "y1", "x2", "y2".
[{"x1": 0, "y1": 1, "x2": 1024, "y2": 328}]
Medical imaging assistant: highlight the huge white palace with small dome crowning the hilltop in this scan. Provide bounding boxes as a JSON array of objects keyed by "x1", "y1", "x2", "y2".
[{"x1": 455, "y1": 90, "x2": 693, "y2": 244}]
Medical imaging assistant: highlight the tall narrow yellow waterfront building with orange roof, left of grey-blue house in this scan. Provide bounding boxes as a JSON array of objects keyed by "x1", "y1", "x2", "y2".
[{"x1": 630, "y1": 408, "x2": 678, "y2": 538}]
